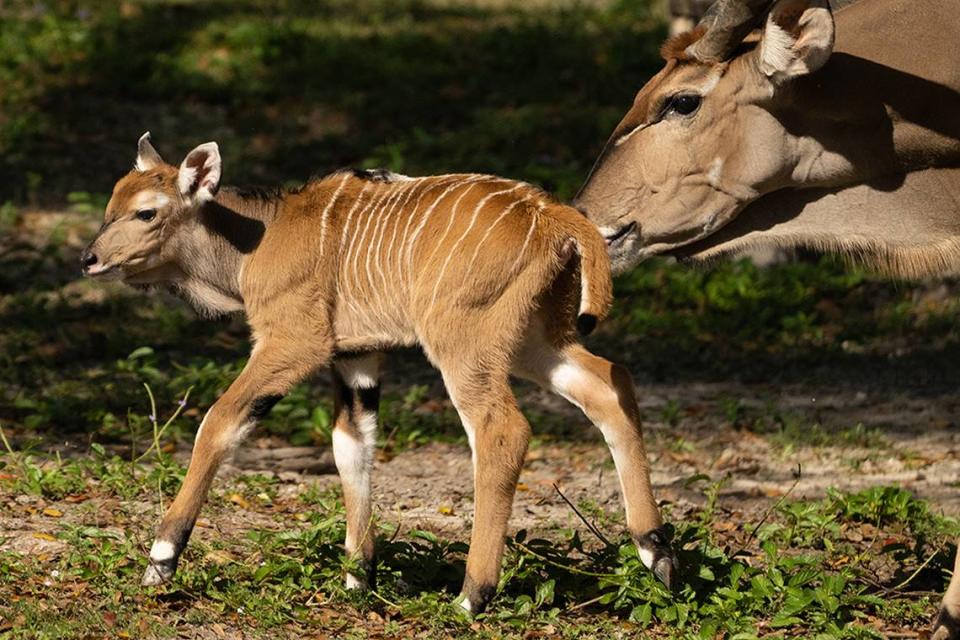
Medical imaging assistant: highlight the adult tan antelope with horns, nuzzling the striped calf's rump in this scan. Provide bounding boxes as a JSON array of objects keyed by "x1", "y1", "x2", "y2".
[{"x1": 577, "y1": 0, "x2": 960, "y2": 639}]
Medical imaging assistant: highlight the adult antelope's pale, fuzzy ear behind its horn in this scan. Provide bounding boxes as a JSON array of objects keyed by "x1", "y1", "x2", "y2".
[{"x1": 760, "y1": 0, "x2": 834, "y2": 82}]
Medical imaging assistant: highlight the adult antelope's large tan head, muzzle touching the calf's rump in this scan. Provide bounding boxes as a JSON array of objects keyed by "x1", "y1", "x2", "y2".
[{"x1": 576, "y1": 0, "x2": 834, "y2": 271}]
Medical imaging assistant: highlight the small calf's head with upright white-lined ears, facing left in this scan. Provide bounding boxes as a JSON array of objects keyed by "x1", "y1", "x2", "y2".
[{"x1": 80, "y1": 133, "x2": 220, "y2": 283}]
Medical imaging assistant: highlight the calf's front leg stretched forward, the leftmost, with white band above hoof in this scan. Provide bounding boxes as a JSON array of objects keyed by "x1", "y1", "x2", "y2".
[{"x1": 142, "y1": 341, "x2": 329, "y2": 586}]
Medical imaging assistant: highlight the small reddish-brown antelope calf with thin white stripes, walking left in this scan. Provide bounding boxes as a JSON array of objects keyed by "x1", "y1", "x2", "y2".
[{"x1": 81, "y1": 134, "x2": 676, "y2": 613}]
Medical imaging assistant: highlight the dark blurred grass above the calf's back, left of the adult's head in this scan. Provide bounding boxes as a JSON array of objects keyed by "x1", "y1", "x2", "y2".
[{"x1": 0, "y1": 0, "x2": 665, "y2": 204}]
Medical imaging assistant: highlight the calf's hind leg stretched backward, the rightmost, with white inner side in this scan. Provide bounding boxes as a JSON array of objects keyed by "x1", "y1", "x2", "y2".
[{"x1": 514, "y1": 334, "x2": 678, "y2": 588}]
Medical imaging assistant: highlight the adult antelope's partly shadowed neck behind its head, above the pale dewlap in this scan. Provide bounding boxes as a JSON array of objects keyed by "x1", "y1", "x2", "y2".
[{"x1": 777, "y1": 0, "x2": 960, "y2": 186}]
